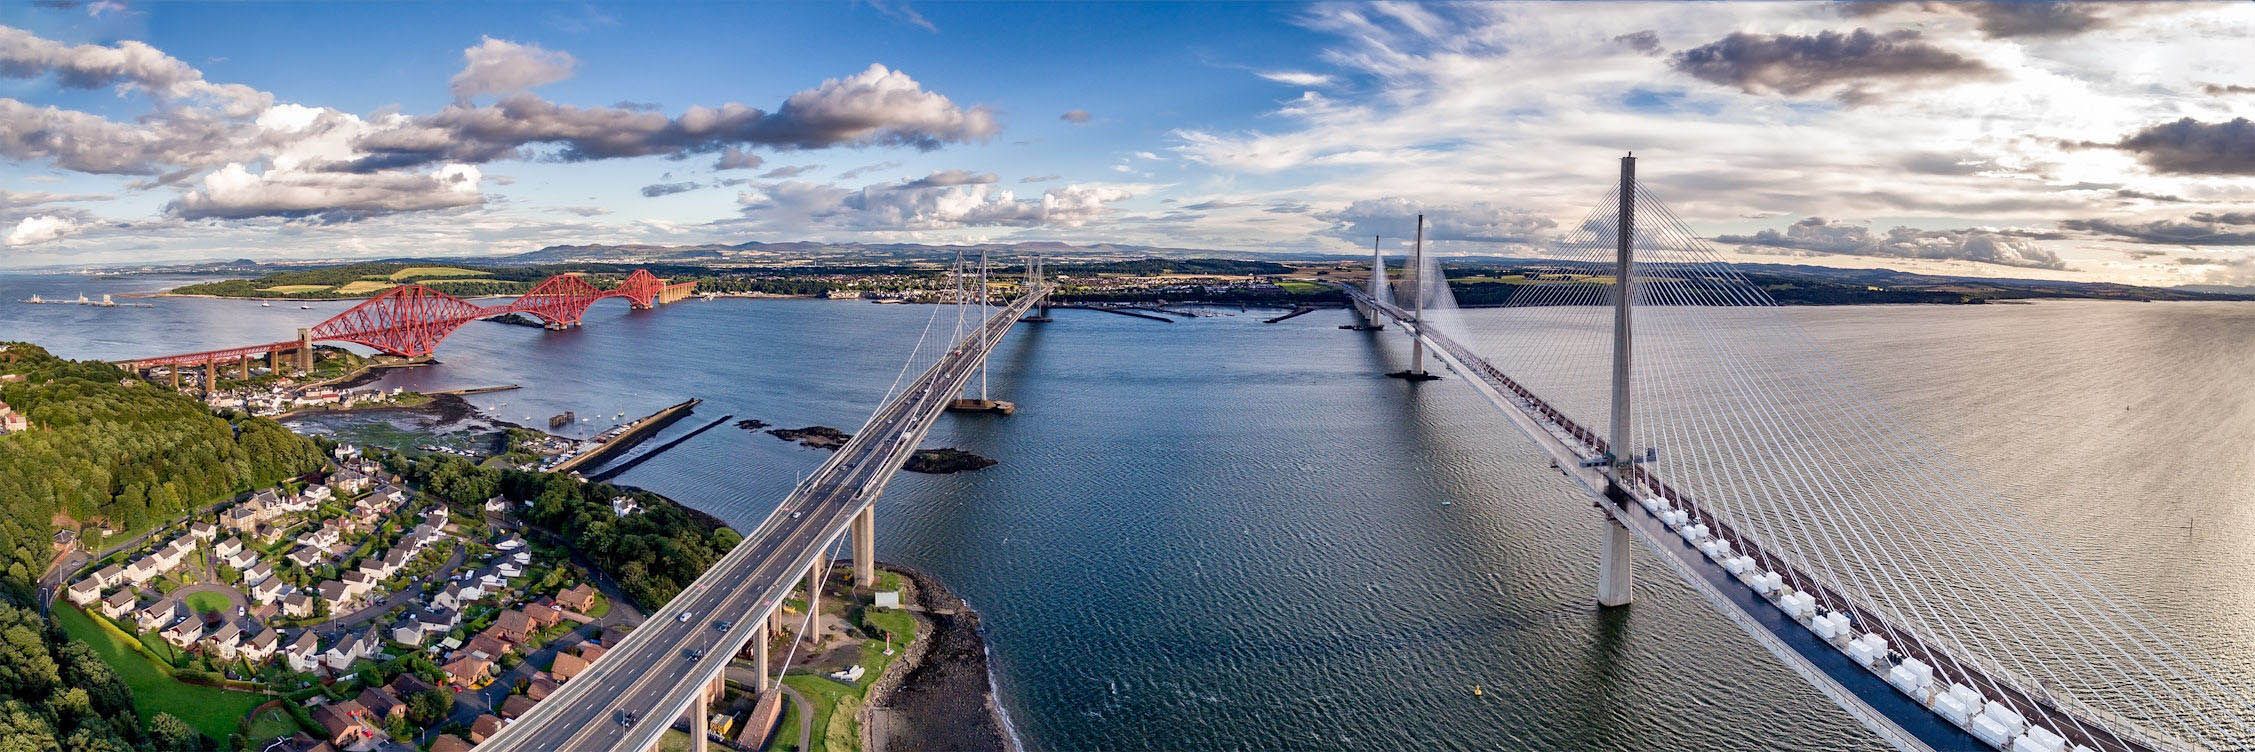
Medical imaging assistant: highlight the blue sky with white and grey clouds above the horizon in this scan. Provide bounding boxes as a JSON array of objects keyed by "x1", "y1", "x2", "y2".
[{"x1": 0, "y1": 2, "x2": 2255, "y2": 285}]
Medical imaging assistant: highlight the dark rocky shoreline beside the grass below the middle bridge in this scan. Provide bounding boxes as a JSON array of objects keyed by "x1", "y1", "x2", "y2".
[{"x1": 861, "y1": 562, "x2": 1017, "y2": 752}]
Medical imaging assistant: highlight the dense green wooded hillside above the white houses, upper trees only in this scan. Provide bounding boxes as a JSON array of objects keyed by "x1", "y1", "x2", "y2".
[{"x1": 0, "y1": 343, "x2": 320, "y2": 603}]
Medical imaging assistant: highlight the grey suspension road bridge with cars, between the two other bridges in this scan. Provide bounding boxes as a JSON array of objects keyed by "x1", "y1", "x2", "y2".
[{"x1": 478, "y1": 264, "x2": 1051, "y2": 752}]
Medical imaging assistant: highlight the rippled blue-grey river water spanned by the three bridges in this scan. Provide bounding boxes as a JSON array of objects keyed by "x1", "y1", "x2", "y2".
[{"x1": 0, "y1": 276, "x2": 2255, "y2": 750}]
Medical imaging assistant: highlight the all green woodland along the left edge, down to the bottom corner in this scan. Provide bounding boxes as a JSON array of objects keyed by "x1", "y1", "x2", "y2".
[{"x1": 0, "y1": 343, "x2": 320, "y2": 752}]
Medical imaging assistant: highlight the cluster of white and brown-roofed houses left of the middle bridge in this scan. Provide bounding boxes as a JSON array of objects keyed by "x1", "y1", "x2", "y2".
[{"x1": 63, "y1": 445, "x2": 609, "y2": 750}]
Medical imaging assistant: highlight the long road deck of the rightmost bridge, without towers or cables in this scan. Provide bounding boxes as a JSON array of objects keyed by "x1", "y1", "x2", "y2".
[{"x1": 1342, "y1": 285, "x2": 2181, "y2": 752}]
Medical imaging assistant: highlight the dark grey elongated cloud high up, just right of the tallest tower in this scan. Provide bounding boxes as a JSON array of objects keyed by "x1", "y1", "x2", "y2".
[{"x1": 1671, "y1": 29, "x2": 1996, "y2": 102}]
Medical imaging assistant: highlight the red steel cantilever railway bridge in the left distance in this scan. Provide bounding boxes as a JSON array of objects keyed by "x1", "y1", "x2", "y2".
[{"x1": 122, "y1": 269, "x2": 697, "y2": 384}]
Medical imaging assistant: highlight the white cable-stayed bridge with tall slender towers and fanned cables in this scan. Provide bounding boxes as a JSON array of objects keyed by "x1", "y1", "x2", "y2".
[{"x1": 1344, "y1": 158, "x2": 2255, "y2": 752}]
